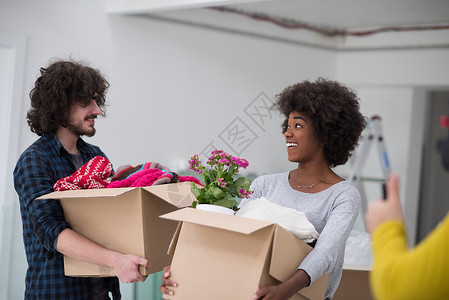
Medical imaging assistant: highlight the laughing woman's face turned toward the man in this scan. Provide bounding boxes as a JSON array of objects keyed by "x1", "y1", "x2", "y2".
[{"x1": 284, "y1": 111, "x2": 324, "y2": 163}]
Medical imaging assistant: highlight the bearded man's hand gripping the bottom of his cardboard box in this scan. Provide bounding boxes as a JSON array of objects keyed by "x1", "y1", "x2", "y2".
[{"x1": 113, "y1": 252, "x2": 150, "y2": 283}]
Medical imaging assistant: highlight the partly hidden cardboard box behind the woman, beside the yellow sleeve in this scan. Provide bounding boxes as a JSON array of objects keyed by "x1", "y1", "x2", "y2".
[{"x1": 334, "y1": 265, "x2": 374, "y2": 300}]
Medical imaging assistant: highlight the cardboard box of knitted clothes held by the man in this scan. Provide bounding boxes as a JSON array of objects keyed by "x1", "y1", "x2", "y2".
[{"x1": 38, "y1": 182, "x2": 195, "y2": 277}]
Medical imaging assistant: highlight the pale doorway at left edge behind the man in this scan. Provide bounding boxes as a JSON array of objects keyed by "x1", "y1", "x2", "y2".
[{"x1": 0, "y1": 34, "x2": 26, "y2": 299}]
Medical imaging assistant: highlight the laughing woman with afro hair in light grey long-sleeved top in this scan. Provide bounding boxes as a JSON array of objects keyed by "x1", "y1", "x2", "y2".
[{"x1": 248, "y1": 78, "x2": 366, "y2": 300}]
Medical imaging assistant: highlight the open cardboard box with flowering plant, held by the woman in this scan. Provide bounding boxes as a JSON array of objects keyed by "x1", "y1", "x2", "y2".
[{"x1": 161, "y1": 208, "x2": 327, "y2": 300}]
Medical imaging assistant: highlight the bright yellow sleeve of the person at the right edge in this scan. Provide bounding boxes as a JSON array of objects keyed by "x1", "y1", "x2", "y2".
[{"x1": 370, "y1": 215, "x2": 449, "y2": 300}]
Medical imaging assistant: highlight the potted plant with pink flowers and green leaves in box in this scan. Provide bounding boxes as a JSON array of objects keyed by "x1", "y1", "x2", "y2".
[{"x1": 189, "y1": 150, "x2": 253, "y2": 213}]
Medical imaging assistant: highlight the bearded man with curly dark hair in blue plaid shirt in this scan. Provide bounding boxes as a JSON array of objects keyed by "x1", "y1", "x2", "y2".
[{"x1": 14, "y1": 60, "x2": 149, "y2": 299}]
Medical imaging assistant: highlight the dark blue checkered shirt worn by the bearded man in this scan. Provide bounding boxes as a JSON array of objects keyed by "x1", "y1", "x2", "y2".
[{"x1": 14, "y1": 134, "x2": 121, "y2": 300}]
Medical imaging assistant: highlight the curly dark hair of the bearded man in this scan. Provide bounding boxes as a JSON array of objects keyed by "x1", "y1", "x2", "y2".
[{"x1": 27, "y1": 60, "x2": 109, "y2": 136}]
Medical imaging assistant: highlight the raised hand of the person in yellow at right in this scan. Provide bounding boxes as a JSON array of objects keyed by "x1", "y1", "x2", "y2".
[{"x1": 365, "y1": 174, "x2": 404, "y2": 233}]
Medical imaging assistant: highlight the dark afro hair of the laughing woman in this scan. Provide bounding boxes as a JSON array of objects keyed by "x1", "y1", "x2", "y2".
[{"x1": 276, "y1": 77, "x2": 366, "y2": 168}]
